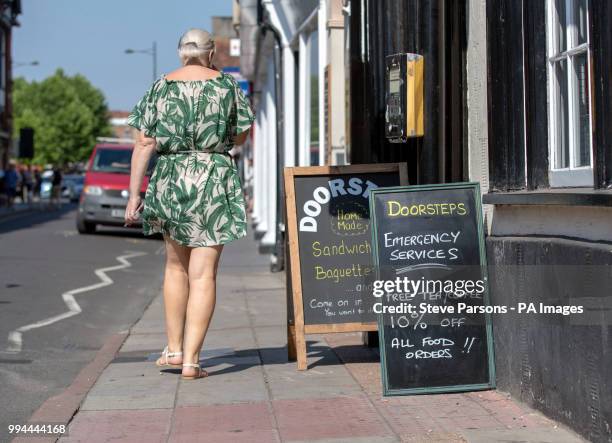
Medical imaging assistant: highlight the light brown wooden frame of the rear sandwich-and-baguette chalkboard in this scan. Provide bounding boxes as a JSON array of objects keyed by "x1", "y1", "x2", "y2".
[{"x1": 284, "y1": 163, "x2": 408, "y2": 371}]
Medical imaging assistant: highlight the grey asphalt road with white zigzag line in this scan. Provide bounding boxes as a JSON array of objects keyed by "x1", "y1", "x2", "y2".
[{"x1": 0, "y1": 205, "x2": 164, "y2": 435}]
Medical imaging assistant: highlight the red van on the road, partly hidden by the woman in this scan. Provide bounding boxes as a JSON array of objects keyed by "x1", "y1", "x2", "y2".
[{"x1": 77, "y1": 144, "x2": 156, "y2": 234}]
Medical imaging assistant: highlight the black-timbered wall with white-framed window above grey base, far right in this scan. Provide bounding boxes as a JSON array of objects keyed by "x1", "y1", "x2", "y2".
[{"x1": 484, "y1": 0, "x2": 612, "y2": 441}]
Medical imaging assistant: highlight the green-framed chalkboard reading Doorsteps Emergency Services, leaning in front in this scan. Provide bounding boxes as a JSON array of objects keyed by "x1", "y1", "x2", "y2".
[{"x1": 370, "y1": 183, "x2": 495, "y2": 395}]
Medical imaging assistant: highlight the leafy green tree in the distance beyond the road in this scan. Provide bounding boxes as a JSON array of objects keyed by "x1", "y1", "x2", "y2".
[{"x1": 13, "y1": 69, "x2": 110, "y2": 164}]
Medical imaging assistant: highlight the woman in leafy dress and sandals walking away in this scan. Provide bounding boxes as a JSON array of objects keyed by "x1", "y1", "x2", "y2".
[{"x1": 125, "y1": 29, "x2": 254, "y2": 379}]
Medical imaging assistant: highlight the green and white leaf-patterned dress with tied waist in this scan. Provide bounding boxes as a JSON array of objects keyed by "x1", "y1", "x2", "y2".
[{"x1": 128, "y1": 73, "x2": 255, "y2": 247}]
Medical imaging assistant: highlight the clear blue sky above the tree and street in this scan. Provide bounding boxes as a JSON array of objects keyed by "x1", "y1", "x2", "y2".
[{"x1": 13, "y1": 0, "x2": 232, "y2": 111}]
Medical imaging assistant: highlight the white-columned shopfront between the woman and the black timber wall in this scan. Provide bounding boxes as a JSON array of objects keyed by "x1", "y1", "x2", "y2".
[{"x1": 235, "y1": 0, "x2": 346, "y2": 269}]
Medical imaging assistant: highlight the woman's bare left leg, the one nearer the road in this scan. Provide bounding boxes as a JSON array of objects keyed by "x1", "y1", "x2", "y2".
[{"x1": 157, "y1": 236, "x2": 191, "y2": 364}]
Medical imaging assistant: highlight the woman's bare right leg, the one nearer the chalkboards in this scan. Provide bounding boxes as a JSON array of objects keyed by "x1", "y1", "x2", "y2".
[{"x1": 183, "y1": 245, "x2": 223, "y2": 376}]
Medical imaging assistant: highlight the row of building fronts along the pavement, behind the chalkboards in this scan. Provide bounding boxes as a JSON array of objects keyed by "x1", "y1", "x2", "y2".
[{"x1": 239, "y1": 0, "x2": 612, "y2": 442}]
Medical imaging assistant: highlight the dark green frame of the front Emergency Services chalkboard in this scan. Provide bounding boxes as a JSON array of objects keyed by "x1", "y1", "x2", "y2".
[{"x1": 370, "y1": 182, "x2": 496, "y2": 396}]
